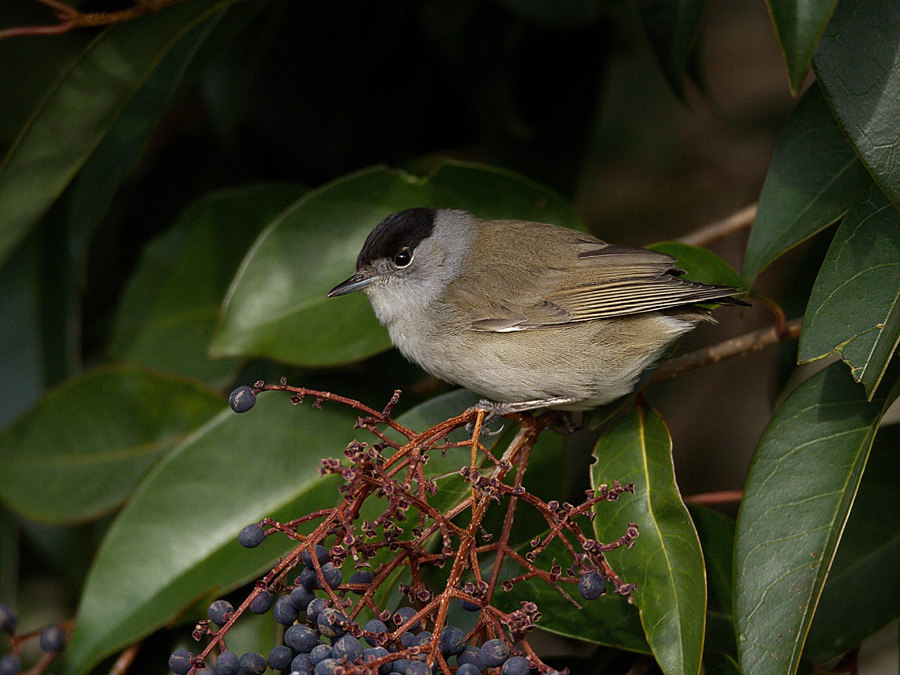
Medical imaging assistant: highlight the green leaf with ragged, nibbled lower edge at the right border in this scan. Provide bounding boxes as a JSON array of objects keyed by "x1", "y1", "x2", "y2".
[{"x1": 797, "y1": 184, "x2": 900, "y2": 398}]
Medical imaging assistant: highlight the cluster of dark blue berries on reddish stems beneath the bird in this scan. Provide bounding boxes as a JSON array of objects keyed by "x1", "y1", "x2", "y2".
[{"x1": 176, "y1": 380, "x2": 638, "y2": 675}]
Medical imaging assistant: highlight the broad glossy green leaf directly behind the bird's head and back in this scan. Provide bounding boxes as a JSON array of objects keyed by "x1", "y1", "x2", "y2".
[{"x1": 211, "y1": 162, "x2": 581, "y2": 366}]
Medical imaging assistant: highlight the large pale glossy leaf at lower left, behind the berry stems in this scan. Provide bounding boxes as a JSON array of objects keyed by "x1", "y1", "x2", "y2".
[{"x1": 62, "y1": 393, "x2": 354, "y2": 675}]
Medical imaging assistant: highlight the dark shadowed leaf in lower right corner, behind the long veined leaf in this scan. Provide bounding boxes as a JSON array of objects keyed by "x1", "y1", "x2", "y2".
[{"x1": 804, "y1": 424, "x2": 900, "y2": 663}]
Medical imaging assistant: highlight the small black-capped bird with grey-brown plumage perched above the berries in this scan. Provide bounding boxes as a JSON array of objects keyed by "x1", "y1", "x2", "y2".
[{"x1": 328, "y1": 208, "x2": 741, "y2": 415}]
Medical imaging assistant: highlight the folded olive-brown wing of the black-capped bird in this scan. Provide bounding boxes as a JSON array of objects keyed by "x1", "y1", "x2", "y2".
[{"x1": 448, "y1": 227, "x2": 740, "y2": 332}]
